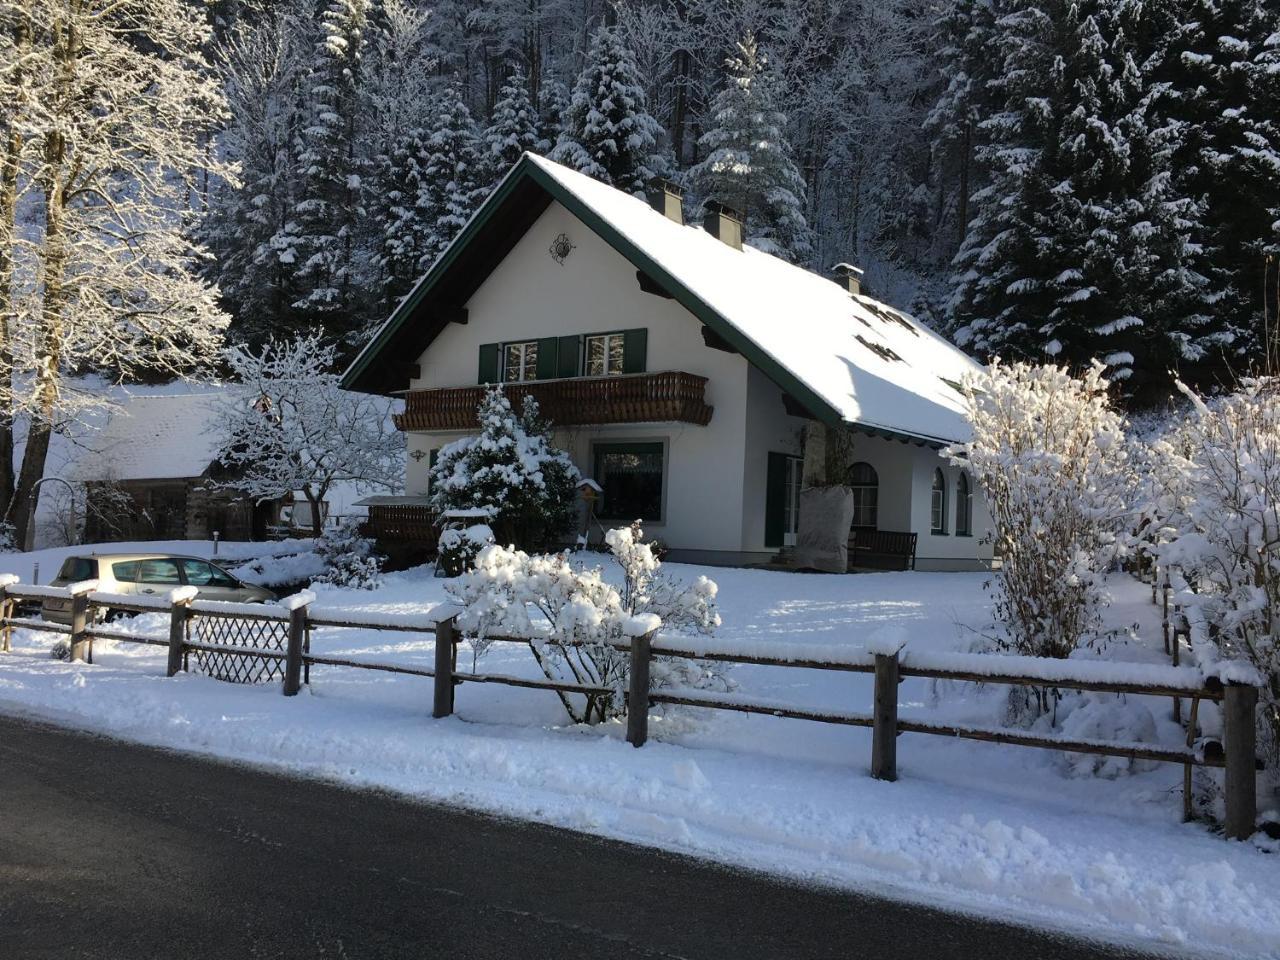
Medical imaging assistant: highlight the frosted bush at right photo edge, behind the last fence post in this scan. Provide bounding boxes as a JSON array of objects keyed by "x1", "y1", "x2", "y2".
[{"x1": 1156, "y1": 379, "x2": 1280, "y2": 767}]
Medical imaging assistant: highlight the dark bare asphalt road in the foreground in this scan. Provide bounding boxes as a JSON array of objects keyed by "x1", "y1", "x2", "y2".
[{"x1": 0, "y1": 718, "x2": 1172, "y2": 960}]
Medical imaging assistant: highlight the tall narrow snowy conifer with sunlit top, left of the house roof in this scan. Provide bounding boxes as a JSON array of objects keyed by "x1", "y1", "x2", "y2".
[{"x1": 275, "y1": 0, "x2": 370, "y2": 338}]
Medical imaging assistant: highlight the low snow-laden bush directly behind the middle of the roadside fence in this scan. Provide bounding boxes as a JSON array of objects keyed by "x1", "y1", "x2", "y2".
[{"x1": 445, "y1": 524, "x2": 730, "y2": 723}]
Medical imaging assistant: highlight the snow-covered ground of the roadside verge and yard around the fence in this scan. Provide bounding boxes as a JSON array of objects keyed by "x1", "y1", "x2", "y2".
[{"x1": 0, "y1": 544, "x2": 1280, "y2": 956}]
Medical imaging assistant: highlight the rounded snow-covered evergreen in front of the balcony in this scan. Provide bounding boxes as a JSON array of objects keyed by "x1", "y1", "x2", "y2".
[{"x1": 431, "y1": 387, "x2": 579, "y2": 549}]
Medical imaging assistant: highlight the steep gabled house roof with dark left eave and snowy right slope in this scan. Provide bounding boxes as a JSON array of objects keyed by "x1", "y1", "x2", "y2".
[{"x1": 343, "y1": 154, "x2": 979, "y2": 443}]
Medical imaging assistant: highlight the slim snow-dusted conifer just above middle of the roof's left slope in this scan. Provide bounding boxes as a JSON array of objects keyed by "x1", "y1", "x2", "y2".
[{"x1": 419, "y1": 82, "x2": 485, "y2": 270}]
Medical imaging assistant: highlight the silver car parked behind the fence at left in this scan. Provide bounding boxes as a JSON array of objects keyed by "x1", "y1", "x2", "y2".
[{"x1": 40, "y1": 553, "x2": 276, "y2": 623}]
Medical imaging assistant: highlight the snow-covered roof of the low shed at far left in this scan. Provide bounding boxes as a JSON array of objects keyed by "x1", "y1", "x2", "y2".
[{"x1": 70, "y1": 390, "x2": 223, "y2": 480}]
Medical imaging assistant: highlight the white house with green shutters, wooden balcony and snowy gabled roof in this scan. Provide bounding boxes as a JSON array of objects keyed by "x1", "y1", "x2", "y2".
[{"x1": 343, "y1": 154, "x2": 991, "y2": 570}]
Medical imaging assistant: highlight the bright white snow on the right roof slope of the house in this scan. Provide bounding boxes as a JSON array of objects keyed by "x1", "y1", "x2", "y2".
[{"x1": 525, "y1": 154, "x2": 980, "y2": 442}]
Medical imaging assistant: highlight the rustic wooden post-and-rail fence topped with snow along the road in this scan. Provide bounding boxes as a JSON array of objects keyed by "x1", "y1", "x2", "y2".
[{"x1": 0, "y1": 584, "x2": 1261, "y2": 840}]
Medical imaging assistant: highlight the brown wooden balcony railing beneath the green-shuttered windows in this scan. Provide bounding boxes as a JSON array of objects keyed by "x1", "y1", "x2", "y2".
[{"x1": 396, "y1": 371, "x2": 712, "y2": 430}]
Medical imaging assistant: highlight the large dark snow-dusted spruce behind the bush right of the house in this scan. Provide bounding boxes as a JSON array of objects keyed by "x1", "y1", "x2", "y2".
[{"x1": 948, "y1": 0, "x2": 1213, "y2": 401}]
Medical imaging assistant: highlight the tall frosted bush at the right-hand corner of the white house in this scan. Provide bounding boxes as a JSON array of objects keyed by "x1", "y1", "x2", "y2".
[{"x1": 950, "y1": 361, "x2": 1129, "y2": 686}]
